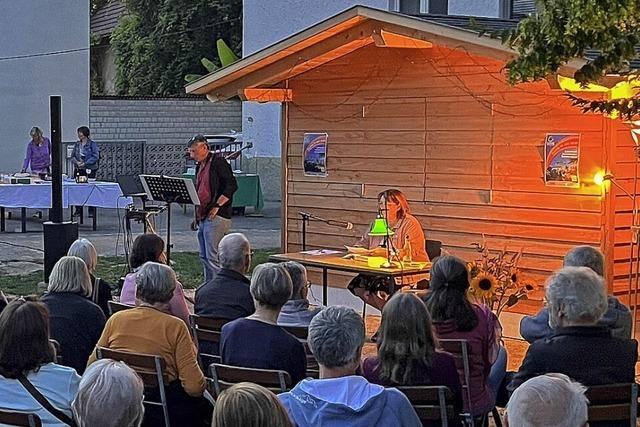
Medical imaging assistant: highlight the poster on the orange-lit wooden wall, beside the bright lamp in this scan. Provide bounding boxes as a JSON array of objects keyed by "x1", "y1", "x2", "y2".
[{"x1": 544, "y1": 133, "x2": 580, "y2": 187}]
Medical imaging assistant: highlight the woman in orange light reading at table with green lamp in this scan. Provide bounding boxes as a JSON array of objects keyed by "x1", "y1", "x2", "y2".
[{"x1": 348, "y1": 189, "x2": 428, "y2": 310}]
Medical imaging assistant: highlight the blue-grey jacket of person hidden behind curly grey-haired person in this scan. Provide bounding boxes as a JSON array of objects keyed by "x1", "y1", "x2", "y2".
[{"x1": 520, "y1": 296, "x2": 631, "y2": 343}]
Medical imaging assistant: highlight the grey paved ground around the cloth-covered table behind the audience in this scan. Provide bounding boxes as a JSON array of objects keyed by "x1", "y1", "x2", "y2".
[{"x1": 0, "y1": 202, "x2": 281, "y2": 274}]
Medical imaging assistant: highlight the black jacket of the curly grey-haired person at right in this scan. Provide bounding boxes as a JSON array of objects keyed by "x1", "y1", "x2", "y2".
[{"x1": 508, "y1": 326, "x2": 638, "y2": 392}]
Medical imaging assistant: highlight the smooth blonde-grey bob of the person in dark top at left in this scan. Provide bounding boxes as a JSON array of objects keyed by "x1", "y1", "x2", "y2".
[{"x1": 47, "y1": 255, "x2": 93, "y2": 297}]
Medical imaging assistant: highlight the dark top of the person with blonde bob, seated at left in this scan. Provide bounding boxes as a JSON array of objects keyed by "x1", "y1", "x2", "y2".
[{"x1": 42, "y1": 292, "x2": 105, "y2": 375}]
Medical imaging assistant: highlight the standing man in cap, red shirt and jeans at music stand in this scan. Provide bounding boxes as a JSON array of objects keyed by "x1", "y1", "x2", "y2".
[{"x1": 189, "y1": 135, "x2": 238, "y2": 283}]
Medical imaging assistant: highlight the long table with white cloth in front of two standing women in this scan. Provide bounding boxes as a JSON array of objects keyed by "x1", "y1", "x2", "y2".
[{"x1": 0, "y1": 181, "x2": 133, "y2": 233}]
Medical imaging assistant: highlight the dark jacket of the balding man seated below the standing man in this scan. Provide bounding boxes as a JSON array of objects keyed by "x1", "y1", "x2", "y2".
[{"x1": 194, "y1": 268, "x2": 256, "y2": 320}]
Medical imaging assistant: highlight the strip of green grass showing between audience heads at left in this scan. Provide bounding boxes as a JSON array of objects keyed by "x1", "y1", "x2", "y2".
[{"x1": 0, "y1": 249, "x2": 280, "y2": 295}]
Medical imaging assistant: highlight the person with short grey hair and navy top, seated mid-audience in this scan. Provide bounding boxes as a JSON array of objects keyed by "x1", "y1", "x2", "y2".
[{"x1": 220, "y1": 263, "x2": 307, "y2": 384}]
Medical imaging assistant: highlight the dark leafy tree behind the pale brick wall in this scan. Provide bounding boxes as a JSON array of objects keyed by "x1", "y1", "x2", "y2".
[{"x1": 111, "y1": 0, "x2": 242, "y2": 96}]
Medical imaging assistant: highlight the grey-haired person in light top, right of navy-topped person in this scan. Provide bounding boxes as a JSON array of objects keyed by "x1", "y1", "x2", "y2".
[{"x1": 278, "y1": 261, "x2": 322, "y2": 328}]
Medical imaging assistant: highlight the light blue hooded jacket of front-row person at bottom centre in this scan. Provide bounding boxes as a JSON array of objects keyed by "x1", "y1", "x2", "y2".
[{"x1": 278, "y1": 375, "x2": 422, "y2": 427}]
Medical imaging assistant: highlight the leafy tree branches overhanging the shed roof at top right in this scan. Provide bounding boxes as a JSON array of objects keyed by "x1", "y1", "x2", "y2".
[{"x1": 501, "y1": 0, "x2": 640, "y2": 119}]
